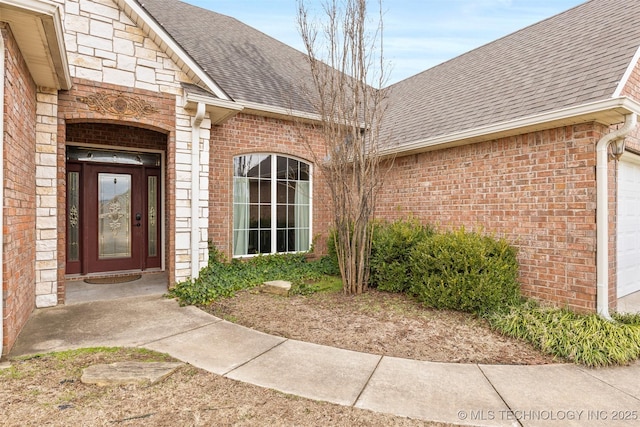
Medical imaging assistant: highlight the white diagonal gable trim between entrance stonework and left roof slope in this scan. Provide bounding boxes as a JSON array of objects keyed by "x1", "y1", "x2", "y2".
[{"x1": 114, "y1": 0, "x2": 233, "y2": 101}]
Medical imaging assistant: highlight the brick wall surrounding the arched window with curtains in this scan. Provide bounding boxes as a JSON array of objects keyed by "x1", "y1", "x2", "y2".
[{"x1": 209, "y1": 114, "x2": 330, "y2": 258}]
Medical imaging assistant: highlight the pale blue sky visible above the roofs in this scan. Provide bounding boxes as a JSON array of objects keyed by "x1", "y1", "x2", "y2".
[{"x1": 183, "y1": 0, "x2": 584, "y2": 84}]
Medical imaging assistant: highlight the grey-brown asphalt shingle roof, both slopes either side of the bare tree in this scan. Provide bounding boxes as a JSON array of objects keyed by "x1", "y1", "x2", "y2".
[{"x1": 139, "y1": 0, "x2": 640, "y2": 145}]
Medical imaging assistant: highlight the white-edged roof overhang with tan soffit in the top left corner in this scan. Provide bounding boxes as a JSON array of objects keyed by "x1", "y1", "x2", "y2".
[{"x1": 0, "y1": 0, "x2": 71, "y2": 90}]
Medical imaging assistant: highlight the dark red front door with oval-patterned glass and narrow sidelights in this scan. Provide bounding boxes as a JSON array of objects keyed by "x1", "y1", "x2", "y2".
[{"x1": 66, "y1": 163, "x2": 161, "y2": 274}]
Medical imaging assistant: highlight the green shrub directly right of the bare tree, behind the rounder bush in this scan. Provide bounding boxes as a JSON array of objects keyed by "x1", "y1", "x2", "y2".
[{"x1": 370, "y1": 218, "x2": 434, "y2": 292}]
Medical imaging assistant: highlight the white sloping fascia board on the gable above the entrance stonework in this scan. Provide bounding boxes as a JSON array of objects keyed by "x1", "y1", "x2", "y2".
[{"x1": 119, "y1": 0, "x2": 231, "y2": 101}]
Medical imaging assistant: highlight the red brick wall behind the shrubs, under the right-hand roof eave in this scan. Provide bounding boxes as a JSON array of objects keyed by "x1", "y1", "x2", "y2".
[{"x1": 378, "y1": 124, "x2": 606, "y2": 311}]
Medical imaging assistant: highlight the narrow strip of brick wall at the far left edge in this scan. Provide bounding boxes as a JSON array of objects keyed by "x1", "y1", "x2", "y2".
[{"x1": 0, "y1": 25, "x2": 36, "y2": 353}]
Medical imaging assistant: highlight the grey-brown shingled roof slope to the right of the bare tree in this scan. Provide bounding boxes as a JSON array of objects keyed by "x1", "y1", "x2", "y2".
[{"x1": 385, "y1": 0, "x2": 640, "y2": 146}]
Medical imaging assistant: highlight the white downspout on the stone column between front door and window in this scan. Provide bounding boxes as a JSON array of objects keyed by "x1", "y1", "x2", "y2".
[{"x1": 191, "y1": 102, "x2": 205, "y2": 279}]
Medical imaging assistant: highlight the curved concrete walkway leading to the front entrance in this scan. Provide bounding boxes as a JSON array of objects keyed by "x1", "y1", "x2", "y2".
[{"x1": 9, "y1": 295, "x2": 640, "y2": 426}]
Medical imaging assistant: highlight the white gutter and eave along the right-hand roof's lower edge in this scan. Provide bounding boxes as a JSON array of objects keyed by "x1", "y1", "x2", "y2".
[{"x1": 380, "y1": 96, "x2": 640, "y2": 156}]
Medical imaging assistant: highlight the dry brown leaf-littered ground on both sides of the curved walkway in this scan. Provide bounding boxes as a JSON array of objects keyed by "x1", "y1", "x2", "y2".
[{"x1": 0, "y1": 290, "x2": 554, "y2": 426}]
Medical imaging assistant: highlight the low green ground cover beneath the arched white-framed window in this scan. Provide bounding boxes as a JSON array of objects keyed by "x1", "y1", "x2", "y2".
[{"x1": 167, "y1": 248, "x2": 338, "y2": 305}]
